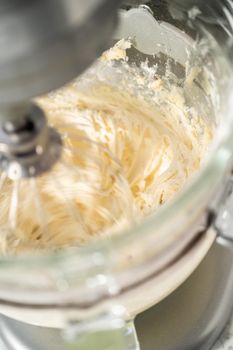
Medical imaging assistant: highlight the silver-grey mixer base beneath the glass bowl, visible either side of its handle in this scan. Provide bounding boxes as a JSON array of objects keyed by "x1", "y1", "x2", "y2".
[{"x1": 0, "y1": 239, "x2": 233, "y2": 350}]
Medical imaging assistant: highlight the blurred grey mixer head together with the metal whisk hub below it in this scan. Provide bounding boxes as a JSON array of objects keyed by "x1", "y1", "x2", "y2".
[{"x1": 0, "y1": 0, "x2": 121, "y2": 178}]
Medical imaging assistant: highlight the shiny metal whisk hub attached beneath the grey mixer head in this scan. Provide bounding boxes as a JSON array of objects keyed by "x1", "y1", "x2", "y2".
[{"x1": 0, "y1": 104, "x2": 62, "y2": 180}]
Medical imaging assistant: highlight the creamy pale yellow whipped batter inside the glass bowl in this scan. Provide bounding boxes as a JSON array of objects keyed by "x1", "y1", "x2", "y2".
[{"x1": 0, "y1": 43, "x2": 212, "y2": 254}]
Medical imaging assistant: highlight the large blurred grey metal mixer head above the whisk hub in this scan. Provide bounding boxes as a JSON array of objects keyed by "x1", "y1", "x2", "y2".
[{"x1": 0, "y1": 0, "x2": 120, "y2": 105}]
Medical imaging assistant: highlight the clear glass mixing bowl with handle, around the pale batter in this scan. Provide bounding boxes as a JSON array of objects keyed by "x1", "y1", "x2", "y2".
[{"x1": 0, "y1": 0, "x2": 233, "y2": 349}]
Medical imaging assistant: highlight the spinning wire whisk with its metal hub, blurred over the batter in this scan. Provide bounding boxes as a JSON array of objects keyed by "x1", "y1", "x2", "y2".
[{"x1": 0, "y1": 100, "x2": 132, "y2": 255}]
